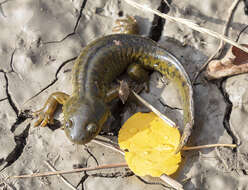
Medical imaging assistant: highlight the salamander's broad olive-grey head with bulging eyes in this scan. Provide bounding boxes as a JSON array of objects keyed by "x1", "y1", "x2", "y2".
[{"x1": 63, "y1": 97, "x2": 109, "y2": 144}]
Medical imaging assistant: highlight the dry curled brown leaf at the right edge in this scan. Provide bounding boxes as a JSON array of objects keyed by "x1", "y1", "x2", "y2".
[{"x1": 206, "y1": 44, "x2": 248, "y2": 80}]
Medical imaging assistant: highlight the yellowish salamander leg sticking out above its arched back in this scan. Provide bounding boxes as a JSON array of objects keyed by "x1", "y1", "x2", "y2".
[{"x1": 112, "y1": 15, "x2": 139, "y2": 34}]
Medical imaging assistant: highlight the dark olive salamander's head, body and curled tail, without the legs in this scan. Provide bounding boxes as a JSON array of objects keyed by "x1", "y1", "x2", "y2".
[{"x1": 63, "y1": 34, "x2": 193, "y2": 150}]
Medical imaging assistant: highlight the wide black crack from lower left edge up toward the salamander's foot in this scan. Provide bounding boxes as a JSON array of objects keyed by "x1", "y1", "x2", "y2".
[{"x1": 0, "y1": 123, "x2": 30, "y2": 172}]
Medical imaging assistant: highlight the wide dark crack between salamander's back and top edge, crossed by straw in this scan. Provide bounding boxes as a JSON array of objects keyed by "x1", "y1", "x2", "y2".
[{"x1": 148, "y1": 0, "x2": 171, "y2": 42}]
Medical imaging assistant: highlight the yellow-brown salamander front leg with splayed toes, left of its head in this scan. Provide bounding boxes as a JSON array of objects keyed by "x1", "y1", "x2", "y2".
[{"x1": 33, "y1": 92, "x2": 69, "y2": 127}]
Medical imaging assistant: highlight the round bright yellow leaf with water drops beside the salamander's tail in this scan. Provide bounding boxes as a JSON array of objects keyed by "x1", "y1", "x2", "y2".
[{"x1": 118, "y1": 113, "x2": 181, "y2": 177}]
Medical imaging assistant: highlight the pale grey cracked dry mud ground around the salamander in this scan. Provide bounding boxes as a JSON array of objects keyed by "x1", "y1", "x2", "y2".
[{"x1": 0, "y1": 0, "x2": 248, "y2": 190}]
